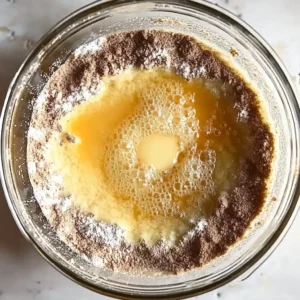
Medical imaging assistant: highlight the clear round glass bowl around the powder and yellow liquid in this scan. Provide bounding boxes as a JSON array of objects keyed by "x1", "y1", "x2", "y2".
[{"x1": 1, "y1": 0, "x2": 299, "y2": 299}]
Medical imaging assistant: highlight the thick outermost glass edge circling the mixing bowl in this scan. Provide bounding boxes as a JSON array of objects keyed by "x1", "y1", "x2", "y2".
[{"x1": 0, "y1": 0, "x2": 300, "y2": 299}]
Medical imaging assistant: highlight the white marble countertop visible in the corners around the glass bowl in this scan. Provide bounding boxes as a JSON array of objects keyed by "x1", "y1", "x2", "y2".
[{"x1": 0, "y1": 0, "x2": 300, "y2": 300}]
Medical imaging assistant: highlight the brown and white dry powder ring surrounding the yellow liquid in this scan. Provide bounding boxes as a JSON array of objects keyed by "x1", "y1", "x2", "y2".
[{"x1": 27, "y1": 31, "x2": 274, "y2": 273}]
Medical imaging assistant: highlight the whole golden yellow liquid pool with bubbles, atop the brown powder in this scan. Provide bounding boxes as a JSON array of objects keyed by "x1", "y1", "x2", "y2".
[{"x1": 49, "y1": 69, "x2": 248, "y2": 244}]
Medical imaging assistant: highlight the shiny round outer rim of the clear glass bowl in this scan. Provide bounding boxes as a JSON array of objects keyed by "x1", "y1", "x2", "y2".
[{"x1": 0, "y1": 0, "x2": 300, "y2": 299}]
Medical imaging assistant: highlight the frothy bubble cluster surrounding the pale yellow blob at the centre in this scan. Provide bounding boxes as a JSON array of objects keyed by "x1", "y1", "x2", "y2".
[{"x1": 104, "y1": 79, "x2": 216, "y2": 216}]
